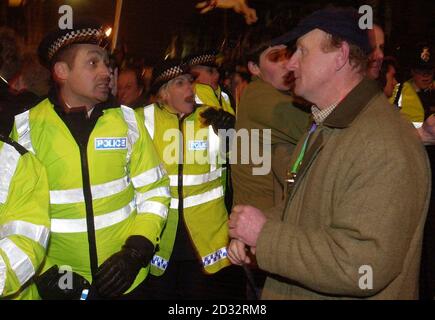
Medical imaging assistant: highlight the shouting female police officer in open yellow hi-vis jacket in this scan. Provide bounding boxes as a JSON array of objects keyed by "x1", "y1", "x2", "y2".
[{"x1": 138, "y1": 60, "x2": 242, "y2": 299}]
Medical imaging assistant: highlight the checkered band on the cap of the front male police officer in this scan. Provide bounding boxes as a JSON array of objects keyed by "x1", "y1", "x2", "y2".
[{"x1": 47, "y1": 28, "x2": 104, "y2": 60}]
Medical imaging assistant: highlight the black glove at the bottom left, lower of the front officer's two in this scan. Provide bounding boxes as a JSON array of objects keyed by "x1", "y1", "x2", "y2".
[{"x1": 35, "y1": 265, "x2": 91, "y2": 300}]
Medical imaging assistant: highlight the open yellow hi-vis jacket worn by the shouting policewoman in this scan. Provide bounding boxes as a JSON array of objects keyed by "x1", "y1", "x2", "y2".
[{"x1": 138, "y1": 104, "x2": 230, "y2": 275}]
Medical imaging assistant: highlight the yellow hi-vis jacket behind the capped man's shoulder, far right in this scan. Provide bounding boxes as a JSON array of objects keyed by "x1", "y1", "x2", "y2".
[{"x1": 390, "y1": 80, "x2": 424, "y2": 122}]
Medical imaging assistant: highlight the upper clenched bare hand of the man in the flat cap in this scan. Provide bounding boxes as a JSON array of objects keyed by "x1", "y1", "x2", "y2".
[{"x1": 228, "y1": 205, "x2": 266, "y2": 247}]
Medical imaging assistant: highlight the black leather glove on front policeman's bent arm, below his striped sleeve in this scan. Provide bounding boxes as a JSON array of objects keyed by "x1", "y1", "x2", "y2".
[{"x1": 93, "y1": 236, "x2": 154, "y2": 298}]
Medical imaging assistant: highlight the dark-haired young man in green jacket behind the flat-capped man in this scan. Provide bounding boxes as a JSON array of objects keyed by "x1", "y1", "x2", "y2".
[{"x1": 231, "y1": 28, "x2": 309, "y2": 296}]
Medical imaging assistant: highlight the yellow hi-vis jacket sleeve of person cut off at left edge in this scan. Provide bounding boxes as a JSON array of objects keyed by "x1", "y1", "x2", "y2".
[{"x1": 0, "y1": 140, "x2": 50, "y2": 299}]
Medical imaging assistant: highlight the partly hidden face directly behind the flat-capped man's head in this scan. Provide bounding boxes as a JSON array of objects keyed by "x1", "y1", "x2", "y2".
[{"x1": 367, "y1": 25, "x2": 385, "y2": 79}]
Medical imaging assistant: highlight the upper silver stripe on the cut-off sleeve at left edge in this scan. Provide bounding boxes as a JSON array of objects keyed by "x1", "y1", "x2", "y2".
[{"x1": 0, "y1": 220, "x2": 50, "y2": 249}]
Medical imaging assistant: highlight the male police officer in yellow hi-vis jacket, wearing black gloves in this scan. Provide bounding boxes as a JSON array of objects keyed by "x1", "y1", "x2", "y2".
[{"x1": 12, "y1": 21, "x2": 170, "y2": 299}]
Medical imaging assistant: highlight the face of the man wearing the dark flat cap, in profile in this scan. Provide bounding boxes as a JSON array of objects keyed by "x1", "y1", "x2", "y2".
[{"x1": 287, "y1": 29, "x2": 338, "y2": 107}]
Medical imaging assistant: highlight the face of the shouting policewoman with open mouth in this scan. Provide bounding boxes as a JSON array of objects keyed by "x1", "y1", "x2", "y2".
[{"x1": 159, "y1": 75, "x2": 195, "y2": 114}]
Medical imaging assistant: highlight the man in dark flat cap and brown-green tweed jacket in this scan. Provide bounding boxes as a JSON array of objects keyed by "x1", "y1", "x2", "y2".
[{"x1": 229, "y1": 8, "x2": 430, "y2": 299}]
